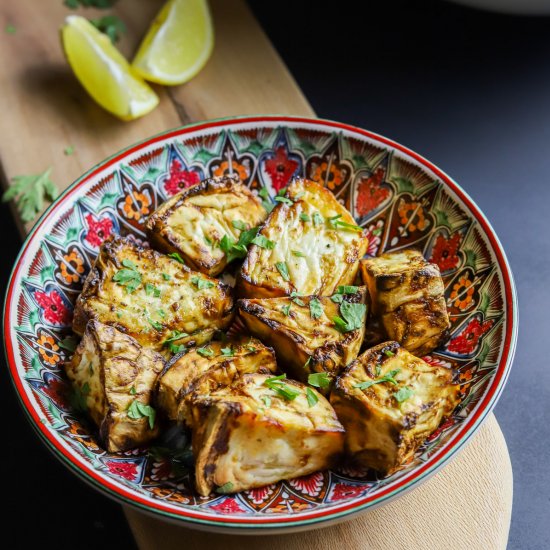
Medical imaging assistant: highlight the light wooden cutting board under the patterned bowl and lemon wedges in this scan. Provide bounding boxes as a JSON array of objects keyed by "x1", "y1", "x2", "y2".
[{"x1": 0, "y1": 0, "x2": 512, "y2": 550}]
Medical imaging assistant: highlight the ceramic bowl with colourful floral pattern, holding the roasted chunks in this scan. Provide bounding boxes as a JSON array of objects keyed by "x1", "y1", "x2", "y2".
[{"x1": 4, "y1": 116, "x2": 517, "y2": 532}]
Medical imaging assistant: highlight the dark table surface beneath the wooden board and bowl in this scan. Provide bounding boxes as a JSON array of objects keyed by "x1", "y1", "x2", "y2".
[{"x1": 0, "y1": 0, "x2": 550, "y2": 550}]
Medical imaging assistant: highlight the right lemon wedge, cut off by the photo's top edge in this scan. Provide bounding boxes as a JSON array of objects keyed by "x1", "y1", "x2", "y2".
[{"x1": 132, "y1": 0, "x2": 214, "y2": 85}]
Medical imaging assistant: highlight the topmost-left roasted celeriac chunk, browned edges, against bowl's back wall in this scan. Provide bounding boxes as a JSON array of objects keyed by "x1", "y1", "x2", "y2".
[{"x1": 146, "y1": 175, "x2": 267, "y2": 276}]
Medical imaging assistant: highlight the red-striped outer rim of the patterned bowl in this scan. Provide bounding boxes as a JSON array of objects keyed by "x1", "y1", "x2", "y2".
[{"x1": 3, "y1": 115, "x2": 518, "y2": 532}]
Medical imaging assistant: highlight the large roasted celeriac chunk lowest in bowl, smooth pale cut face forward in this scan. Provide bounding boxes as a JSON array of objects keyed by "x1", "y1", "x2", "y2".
[{"x1": 191, "y1": 374, "x2": 344, "y2": 496}]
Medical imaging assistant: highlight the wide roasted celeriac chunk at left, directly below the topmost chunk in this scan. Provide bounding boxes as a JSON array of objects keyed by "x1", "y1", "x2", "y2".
[{"x1": 73, "y1": 237, "x2": 233, "y2": 350}]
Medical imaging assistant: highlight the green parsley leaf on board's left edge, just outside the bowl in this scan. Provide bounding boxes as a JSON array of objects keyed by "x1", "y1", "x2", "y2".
[{"x1": 2, "y1": 168, "x2": 58, "y2": 222}]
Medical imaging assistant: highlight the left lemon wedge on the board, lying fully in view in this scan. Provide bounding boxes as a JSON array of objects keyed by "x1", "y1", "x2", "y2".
[{"x1": 61, "y1": 15, "x2": 159, "y2": 120}]
